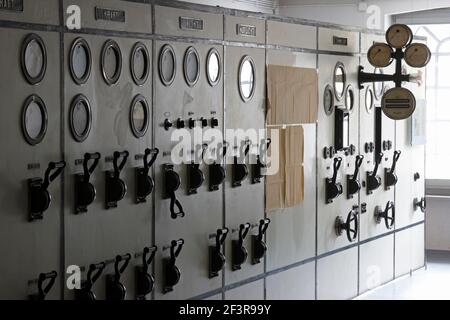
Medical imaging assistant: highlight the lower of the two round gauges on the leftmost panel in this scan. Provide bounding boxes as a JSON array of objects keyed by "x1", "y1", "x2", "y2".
[{"x1": 22, "y1": 95, "x2": 48, "y2": 146}]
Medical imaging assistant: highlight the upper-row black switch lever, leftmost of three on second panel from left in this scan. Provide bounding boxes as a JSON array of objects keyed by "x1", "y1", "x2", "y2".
[{"x1": 75, "y1": 152, "x2": 101, "y2": 214}]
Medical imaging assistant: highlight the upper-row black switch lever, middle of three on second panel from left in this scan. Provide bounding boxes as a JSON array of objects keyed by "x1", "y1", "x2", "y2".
[{"x1": 105, "y1": 151, "x2": 129, "y2": 209}]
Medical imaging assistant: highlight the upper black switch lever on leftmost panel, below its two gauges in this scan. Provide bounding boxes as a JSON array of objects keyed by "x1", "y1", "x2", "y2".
[{"x1": 28, "y1": 161, "x2": 66, "y2": 221}]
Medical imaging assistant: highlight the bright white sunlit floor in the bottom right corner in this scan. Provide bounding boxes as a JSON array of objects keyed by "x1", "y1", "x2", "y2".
[{"x1": 357, "y1": 251, "x2": 450, "y2": 300}]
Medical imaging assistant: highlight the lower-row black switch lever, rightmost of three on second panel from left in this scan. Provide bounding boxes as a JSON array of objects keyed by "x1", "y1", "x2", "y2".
[{"x1": 136, "y1": 246, "x2": 158, "y2": 300}]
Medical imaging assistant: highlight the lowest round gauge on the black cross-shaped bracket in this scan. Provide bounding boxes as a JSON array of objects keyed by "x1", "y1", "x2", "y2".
[{"x1": 381, "y1": 88, "x2": 416, "y2": 120}]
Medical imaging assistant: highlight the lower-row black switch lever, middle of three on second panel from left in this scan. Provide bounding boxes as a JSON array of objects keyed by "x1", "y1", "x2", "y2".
[{"x1": 106, "y1": 253, "x2": 131, "y2": 301}]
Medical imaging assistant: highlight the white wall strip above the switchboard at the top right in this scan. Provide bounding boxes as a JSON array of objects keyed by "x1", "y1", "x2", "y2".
[{"x1": 277, "y1": 0, "x2": 450, "y2": 29}]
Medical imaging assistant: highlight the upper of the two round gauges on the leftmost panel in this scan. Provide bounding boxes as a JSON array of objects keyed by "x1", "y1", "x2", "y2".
[{"x1": 21, "y1": 33, "x2": 47, "y2": 85}]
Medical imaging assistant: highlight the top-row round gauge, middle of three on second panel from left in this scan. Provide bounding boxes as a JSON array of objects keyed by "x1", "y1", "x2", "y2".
[{"x1": 101, "y1": 40, "x2": 122, "y2": 85}]
